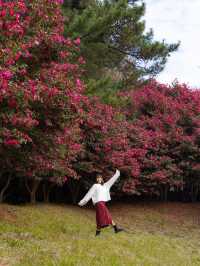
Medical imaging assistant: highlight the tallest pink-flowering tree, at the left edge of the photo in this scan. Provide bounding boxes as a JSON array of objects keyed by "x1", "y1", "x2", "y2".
[{"x1": 0, "y1": 0, "x2": 85, "y2": 202}]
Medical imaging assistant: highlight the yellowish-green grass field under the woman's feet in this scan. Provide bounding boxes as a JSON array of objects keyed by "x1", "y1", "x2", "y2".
[{"x1": 0, "y1": 203, "x2": 200, "y2": 266}]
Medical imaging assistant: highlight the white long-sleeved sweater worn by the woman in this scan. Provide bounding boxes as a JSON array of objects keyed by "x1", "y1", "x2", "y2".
[{"x1": 78, "y1": 170, "x2": 120, "y2": 206}]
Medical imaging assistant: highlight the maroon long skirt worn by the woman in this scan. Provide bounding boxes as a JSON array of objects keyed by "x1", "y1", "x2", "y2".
[{"x1": 95, "y1": 201, "x2": 112, "y2": 228}]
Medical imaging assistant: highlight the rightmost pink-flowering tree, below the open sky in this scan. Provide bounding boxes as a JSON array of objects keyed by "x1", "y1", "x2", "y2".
[{"x1": 124, "y1": 81, "x2": 200, "y2": 200}]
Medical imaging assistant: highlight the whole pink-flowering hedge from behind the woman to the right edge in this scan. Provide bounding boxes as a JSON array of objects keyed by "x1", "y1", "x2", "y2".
[{"x1": 74, "y1": 81, "x2": 200, "y2": 201}]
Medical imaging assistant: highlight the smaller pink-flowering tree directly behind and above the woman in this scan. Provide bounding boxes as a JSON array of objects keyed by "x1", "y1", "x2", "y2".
[{"x1": 75, "y1": 94, "x2": 143, "y2": 197}]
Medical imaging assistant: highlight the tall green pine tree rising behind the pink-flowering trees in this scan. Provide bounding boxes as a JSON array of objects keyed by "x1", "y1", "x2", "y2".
[{"x1": 63, "y1": 0, "x2": 179, "y2": 101}]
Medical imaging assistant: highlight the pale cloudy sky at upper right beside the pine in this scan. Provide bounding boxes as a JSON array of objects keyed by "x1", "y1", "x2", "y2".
[{"x1": 144, "y1": 0, "x2": 200, "y2": 88}]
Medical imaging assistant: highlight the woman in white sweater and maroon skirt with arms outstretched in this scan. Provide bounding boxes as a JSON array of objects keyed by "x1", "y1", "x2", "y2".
[{"x1": 78, "y1": 170, "x2": 123, "y2": 236}]
